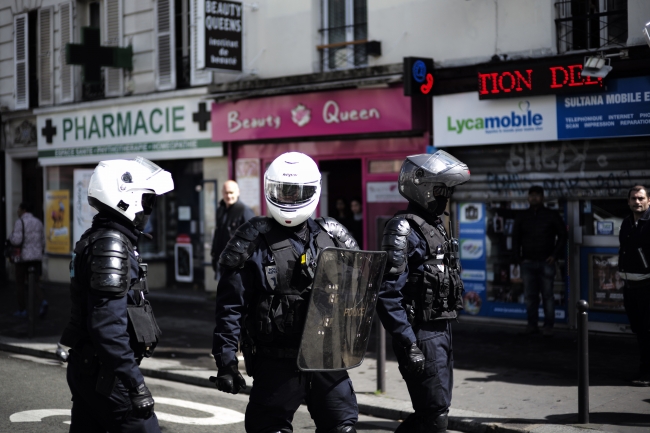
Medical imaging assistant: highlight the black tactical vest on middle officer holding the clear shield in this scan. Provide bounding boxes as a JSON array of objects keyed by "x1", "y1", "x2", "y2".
[{"x1": 246, "y1": 227, "x2": 337, "y2": 343}]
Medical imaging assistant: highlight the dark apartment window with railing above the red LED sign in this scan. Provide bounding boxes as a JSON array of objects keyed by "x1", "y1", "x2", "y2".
[{"x1": 555, "y1": 0, "x2": 628, "y2": 53}]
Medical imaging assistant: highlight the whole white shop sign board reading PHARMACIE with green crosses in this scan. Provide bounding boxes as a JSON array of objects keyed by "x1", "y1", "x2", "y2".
[{"x1": 36, "y1": 97, "x2": 223, "y2": 165}]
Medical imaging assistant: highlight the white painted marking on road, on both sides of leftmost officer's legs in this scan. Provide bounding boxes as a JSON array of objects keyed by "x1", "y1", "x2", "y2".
[{"x1": 9, "y1": 397, "x2": 244, "y2": 425}]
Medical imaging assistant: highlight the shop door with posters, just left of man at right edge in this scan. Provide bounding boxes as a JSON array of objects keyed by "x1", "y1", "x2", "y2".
[{"x1": 570, "y1": 197, "x2": 630, "y2": 332}]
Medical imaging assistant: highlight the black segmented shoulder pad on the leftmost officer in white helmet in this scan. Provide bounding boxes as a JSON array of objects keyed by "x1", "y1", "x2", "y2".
[{"x1": 88, "y1": 230, "x2": 131, "y2": 297}]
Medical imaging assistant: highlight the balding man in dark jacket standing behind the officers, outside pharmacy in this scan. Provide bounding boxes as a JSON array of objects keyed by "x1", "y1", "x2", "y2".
[{"x1": 210, "y1": 180, "x2": 255, "y2": 280}]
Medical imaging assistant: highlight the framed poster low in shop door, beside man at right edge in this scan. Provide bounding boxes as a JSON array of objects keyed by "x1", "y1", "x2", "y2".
[{"x1": 588, "y1": 254, "x2": 625, "y2": 312}]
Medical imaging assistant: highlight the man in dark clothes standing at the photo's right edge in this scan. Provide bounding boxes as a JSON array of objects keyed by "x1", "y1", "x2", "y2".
[{"x1": 618, "y1": 185, "x2": 650, "y2": 386}]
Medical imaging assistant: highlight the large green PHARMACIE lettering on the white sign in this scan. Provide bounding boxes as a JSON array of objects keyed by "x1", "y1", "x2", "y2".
[{"x1": 62, "y1": 106, "x2": 185, "y2": 141}]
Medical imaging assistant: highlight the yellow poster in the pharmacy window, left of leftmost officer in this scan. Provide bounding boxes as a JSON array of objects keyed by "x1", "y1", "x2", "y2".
[{"x1": 45, "y1": 189, "x2": 70, "y2": 254}]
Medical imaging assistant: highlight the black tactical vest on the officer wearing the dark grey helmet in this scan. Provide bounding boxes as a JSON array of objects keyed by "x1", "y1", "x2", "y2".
[{"x1": 399, "y1": 214, "x2": 463, "y2": 323}]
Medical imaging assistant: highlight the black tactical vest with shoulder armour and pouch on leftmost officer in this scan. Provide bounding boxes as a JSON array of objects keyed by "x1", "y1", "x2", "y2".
[{"x1": 61, "y1": 229, "x2": 162, "y2": 359}]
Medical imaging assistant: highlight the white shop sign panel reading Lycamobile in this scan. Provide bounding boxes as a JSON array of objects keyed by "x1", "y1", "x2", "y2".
[{"x1": 433, "y1": 93, "x2": 557, "y2": 147}]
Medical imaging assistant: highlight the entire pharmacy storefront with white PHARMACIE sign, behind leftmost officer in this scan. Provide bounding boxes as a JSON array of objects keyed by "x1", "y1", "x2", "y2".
[{"x1": 36, "y1": 91, "x2": 227, "y2": 287}]
